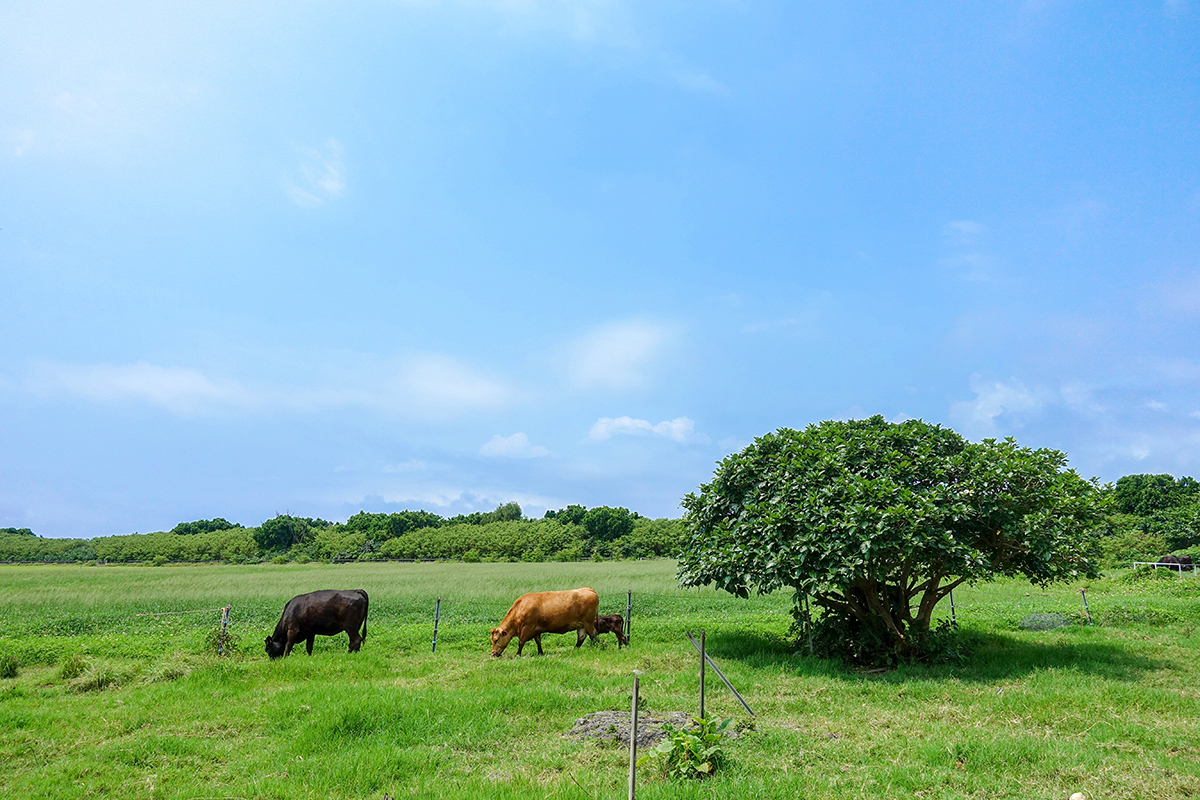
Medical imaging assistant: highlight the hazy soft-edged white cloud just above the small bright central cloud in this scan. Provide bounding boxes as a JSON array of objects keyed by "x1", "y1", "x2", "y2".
[{"x1": 568, "y1": 320, "x2": 674, "y2": 390}]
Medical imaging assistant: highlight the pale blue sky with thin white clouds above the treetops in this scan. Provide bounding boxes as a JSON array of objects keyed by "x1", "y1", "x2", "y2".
[{"x1": 0, "y1": 0, "x2": 1200, "y2": 536}]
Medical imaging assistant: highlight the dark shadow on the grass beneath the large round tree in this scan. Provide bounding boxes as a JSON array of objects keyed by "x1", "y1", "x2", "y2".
[{"x1": 704, "y1": 631, "x2": 1172, "y2": 684}]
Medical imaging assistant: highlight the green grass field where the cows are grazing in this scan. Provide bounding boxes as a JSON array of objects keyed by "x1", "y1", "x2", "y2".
[{"x1": 0, "y1": 561, "x2": 1200, "y2": 800}]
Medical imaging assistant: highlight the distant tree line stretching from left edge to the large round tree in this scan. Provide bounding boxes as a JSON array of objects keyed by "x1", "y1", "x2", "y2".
[{"x1": 0, "y1": 503, "x2": 684, "y2": 564}]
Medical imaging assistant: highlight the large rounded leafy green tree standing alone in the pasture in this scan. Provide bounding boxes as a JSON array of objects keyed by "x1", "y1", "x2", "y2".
[{"x1": 679, "y1": 416, "x2": 1103, "y2": 662}]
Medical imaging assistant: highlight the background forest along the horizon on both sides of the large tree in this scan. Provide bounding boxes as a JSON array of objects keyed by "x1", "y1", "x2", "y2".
[{"x1": 0, "y1": 475, "x2": 1200, "y2": 567}]
